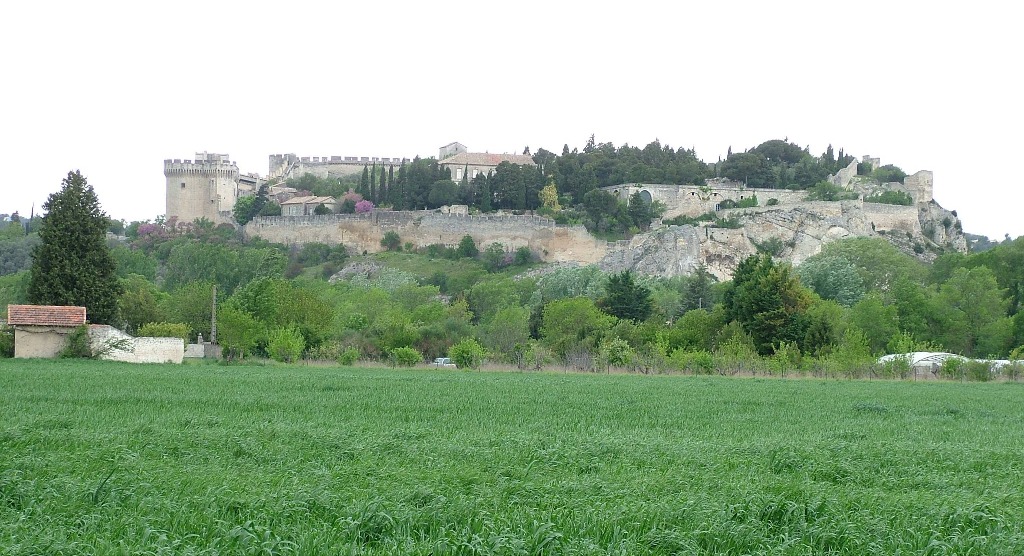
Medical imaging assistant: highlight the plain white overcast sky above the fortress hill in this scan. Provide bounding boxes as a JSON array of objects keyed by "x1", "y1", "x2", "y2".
[{"x1": 0, "y1": 0, "x2": 1024, "y2": 239}]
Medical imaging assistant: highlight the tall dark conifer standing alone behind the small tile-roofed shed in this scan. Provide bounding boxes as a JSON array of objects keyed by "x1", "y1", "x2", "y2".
[{"x1": 29, "y1": 170, "x2": 122, "y2": 325}]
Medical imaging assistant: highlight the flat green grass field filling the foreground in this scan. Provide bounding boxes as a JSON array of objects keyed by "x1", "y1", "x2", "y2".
[{"x1": 0, "y1": 359, "x2": 1024, "y2": 555}]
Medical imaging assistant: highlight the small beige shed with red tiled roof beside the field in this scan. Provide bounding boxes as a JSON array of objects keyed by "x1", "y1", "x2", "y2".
[{"x1": 7, "y1": 305, "x2": 85, "y2": 357}]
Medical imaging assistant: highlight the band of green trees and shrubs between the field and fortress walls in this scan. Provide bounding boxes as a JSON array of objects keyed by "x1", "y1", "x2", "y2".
[{"x1": 0, "y1": 212, "x2": 1024, "y2": 364}]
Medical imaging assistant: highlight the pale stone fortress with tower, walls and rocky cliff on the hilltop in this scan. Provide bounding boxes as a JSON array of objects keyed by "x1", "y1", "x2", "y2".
[{"x1": 164, "y1": 149, "x2": 967, "y2": 279}]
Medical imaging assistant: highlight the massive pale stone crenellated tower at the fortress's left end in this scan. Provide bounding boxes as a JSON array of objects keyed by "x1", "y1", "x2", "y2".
[{"x1": 164, "y1": 153, "x2": 239, "y2": 224}]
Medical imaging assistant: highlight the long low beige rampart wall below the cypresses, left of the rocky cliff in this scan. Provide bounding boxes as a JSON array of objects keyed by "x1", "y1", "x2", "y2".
[{"x1": 245, "y1": 211, "x2": 608, "y2": 264}]
